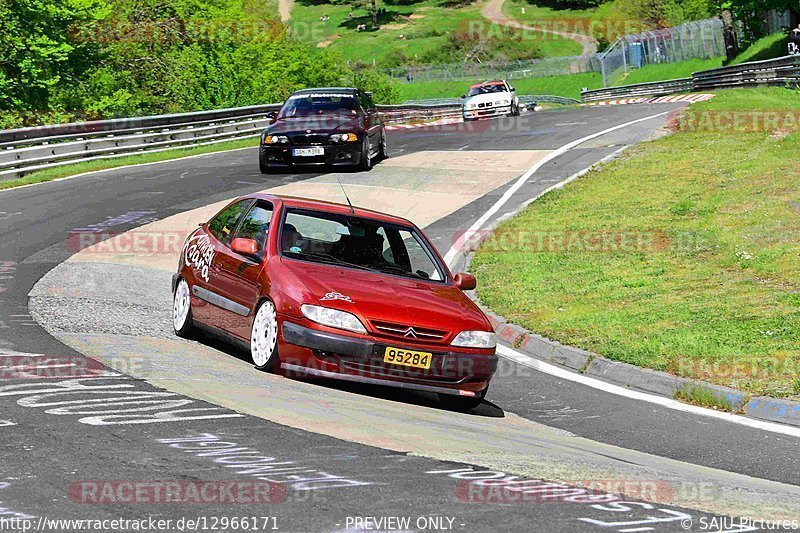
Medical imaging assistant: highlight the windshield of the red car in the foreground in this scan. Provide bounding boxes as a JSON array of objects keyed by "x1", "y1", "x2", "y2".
[{"x1": 281, "y1": 209, "x2": 445, "y2": 281}]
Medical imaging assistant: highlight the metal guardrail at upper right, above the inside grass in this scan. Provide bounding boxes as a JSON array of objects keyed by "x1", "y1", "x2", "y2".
[{"x1": 581, "y1": 56, "x2": 800, "y2": 102}]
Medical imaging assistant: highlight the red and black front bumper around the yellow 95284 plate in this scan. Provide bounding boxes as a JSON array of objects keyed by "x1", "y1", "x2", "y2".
[{"x1": 279, "y1": 320, "x2": 497, "y2": 396}]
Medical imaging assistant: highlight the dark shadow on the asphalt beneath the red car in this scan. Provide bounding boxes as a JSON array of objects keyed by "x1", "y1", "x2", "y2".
[{"x1": 191, "y1": 330, "x2": 506, "y2": 418}]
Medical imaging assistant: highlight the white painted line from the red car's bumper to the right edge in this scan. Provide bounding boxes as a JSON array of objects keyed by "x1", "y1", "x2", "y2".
[{"x1": 497, "y1": 344, "x2": 800, "y2": 437}]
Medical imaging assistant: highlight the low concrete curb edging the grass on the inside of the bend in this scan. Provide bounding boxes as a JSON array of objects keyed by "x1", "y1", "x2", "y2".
[{"x1": 464, "y1": 157, "x2": 800, "y2": 427}]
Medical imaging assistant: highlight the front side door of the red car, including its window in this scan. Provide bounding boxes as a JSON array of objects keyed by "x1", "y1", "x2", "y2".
[{"x1": 216, "y1": 201, "x2": 273, "y2": 340}]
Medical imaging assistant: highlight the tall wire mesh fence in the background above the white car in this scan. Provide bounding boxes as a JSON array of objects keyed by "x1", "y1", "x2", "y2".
[{"x1": 386, "y1": 18, "x2": 725, "y2": 87}]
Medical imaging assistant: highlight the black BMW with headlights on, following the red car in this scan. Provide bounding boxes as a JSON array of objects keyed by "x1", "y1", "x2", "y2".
[{"x1": 259, "y1": 88, "x2": 386, "y2": 174}]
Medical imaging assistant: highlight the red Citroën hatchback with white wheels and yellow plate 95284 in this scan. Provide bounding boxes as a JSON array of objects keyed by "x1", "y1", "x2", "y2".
[{"x1": 172, "y1": 194, "x2": 497, "y2": 409}]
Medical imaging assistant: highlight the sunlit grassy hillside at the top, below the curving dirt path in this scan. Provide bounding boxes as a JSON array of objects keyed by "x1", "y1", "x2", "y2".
[{"x1": 289, "y1": 0, "x2": 582, "y2": 67}]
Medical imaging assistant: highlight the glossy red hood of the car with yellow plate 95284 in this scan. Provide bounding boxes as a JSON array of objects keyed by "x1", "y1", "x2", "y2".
[{"x1": 281, "y1": 258, "x2": 492, "y2": 334}]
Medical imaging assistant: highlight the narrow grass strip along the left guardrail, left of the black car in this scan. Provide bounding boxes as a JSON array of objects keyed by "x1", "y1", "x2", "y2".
[{"x1": 0, "y1": 138, "x2": 258, "y2": 190}]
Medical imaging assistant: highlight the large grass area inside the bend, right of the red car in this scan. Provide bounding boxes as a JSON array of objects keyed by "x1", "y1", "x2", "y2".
[{"x1": 472, "y1": 88, "x2": 800, "y2": 398}]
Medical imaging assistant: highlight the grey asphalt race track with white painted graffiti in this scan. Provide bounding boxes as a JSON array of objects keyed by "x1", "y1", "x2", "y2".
[{"x1": 0, "y1": 105, "x2": 800, "y2": 531}]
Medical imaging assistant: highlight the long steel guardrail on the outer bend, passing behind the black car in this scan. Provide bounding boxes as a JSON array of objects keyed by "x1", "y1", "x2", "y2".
[{"x1": 0, "y1": 96, "x2": 577, "y2": 184}]
